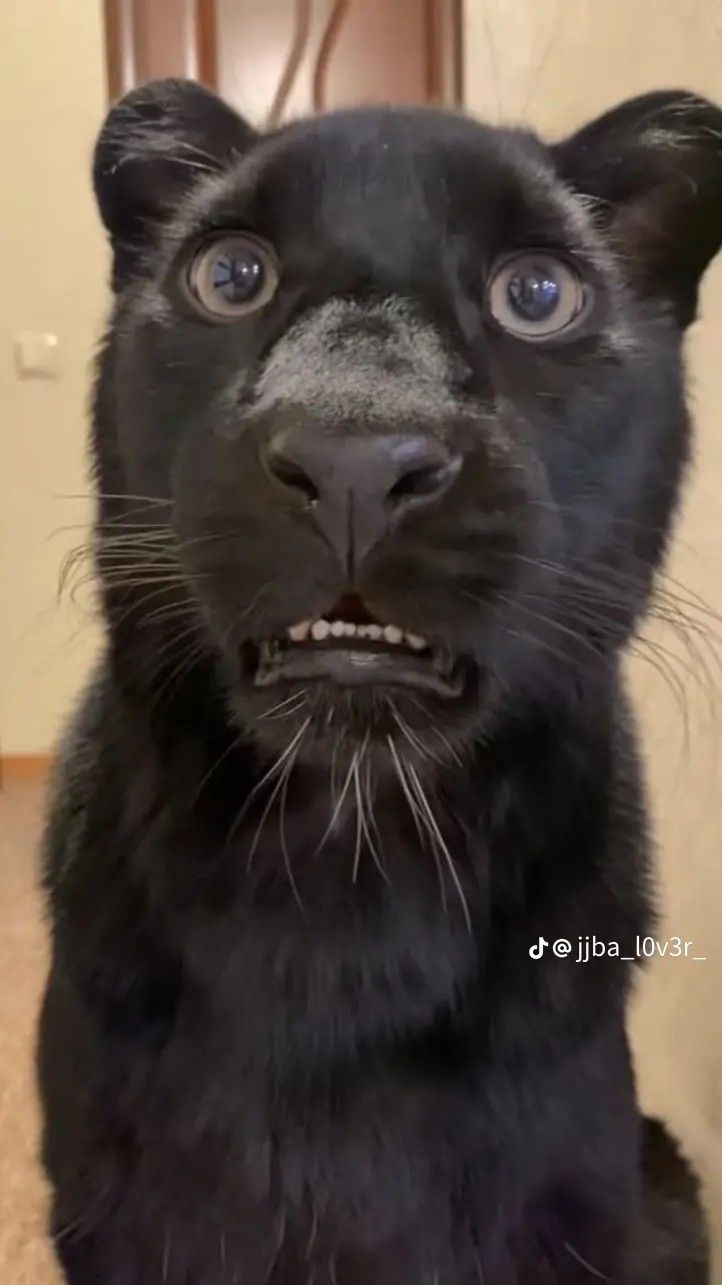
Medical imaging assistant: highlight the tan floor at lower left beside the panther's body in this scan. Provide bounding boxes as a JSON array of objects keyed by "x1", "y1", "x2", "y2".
[{"x1": 0, "y1": 765, "x2": 60, "y2": 1285}]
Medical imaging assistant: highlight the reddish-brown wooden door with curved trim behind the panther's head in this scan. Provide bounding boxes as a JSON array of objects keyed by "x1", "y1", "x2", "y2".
[{"x1": 105, "y1": 0, "x2": 461, "y2": 125}]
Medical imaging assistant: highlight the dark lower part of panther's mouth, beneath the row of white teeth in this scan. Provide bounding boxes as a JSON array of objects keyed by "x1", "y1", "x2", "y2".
[{"x1": 247, "y1": 644, "x2": 464, "y2": 700}]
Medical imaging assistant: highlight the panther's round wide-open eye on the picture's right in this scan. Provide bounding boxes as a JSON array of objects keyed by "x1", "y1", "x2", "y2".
[{"x1": 488, "y1": 251, "x2": 590, "y2": 341}]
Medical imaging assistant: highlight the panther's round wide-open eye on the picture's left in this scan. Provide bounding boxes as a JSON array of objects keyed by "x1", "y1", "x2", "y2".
[{"x1": 186, "y1": 233, "x2": 279, "y2": 321}]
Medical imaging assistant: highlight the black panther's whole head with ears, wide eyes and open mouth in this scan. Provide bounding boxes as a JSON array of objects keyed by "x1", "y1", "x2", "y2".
[{"x1": 89, "y1": 81, "x2": 722, "y2": 748}]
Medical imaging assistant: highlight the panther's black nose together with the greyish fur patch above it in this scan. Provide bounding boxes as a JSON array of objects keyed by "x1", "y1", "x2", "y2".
[{"x1": 256, "y1": 297, "x2": 459, "y2": 574}]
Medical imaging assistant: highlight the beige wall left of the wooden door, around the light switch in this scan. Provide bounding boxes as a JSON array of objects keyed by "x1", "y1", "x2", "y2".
[{"x1": 0, "y1": 0, "x2": 105, "y2": 754}]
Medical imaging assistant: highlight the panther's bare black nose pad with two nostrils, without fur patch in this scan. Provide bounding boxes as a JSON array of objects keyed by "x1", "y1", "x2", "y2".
[{"x1": 263, "y1": 425, "x2": 461, "y2": 572}]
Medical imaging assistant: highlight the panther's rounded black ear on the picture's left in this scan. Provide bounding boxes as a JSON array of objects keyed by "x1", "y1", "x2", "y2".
[{"x1": 92, "y1": 80, "x2": 256, "y2": 290}]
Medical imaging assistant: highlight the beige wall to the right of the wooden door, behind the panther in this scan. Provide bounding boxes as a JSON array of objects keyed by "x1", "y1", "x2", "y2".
[{"x1": 466, "y1": 0, "x2": 722, "y2": 1264}]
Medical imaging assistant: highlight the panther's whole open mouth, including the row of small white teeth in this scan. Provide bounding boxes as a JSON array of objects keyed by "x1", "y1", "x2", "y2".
[{"x1": 246, "y1": 594, "x2": 462, "y2": 696}]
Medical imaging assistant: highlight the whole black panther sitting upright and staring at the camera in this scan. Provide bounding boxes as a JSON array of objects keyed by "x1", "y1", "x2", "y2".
[{"x1": 39, "y1": 81, "x2": 722, "y2": 1285}]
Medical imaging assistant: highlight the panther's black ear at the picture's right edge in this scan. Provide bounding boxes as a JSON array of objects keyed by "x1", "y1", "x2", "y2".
[{"x1": 554, "y1": 90, "x2": 722, "y2": 328}]
